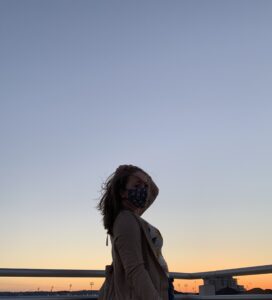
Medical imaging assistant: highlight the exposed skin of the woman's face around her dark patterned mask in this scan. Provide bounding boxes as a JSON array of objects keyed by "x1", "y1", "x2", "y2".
[{"x1": 121, "y1": 171, "x2": 149, "y2": 215}]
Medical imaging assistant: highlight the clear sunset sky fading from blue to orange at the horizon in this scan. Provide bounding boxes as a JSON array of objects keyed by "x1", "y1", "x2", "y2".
[{"x1": 0, "y1": 0, "x2": 272, "y2": 290}]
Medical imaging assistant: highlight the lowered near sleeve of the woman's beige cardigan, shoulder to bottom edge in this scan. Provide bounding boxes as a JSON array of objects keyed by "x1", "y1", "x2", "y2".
[{"x1": 113, "y1": 211, "x2": 162, "y2": 300}]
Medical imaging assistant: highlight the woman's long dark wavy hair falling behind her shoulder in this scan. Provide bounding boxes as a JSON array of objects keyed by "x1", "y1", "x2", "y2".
[{"x1": 96, "y1": 165, "x2": 147, "y2": 235}]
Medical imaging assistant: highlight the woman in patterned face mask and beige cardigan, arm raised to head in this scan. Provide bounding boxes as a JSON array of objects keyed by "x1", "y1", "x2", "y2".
[{"x1": 97, "y1": 165, "x2": 174, "y2": 300}]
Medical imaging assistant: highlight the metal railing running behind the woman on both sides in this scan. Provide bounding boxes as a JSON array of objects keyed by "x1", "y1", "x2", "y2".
[{"x1": 0, "y1": 265, "x2": 272, "y2": 300}]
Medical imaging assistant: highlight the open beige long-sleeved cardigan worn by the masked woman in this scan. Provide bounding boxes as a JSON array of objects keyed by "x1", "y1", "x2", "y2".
[{"x1": 98, "y1": 209, "x2": 168, "y2": 300}]
